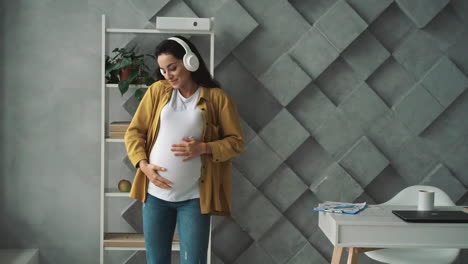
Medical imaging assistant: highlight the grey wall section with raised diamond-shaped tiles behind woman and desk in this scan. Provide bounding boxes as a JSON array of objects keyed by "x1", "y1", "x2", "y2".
[{"x1": 103, "y1": 0, "x2": 468, "y2": 264}]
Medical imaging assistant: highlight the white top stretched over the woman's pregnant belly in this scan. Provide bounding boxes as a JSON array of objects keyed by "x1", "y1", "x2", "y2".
[{"x1": 148, "y1": 88, "x2": 203, "y2": 202}]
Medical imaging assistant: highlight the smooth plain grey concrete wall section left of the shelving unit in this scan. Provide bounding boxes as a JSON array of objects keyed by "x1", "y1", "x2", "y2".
[{"x1": 0, "y1": 1, "x2": 100, "y2": 263}]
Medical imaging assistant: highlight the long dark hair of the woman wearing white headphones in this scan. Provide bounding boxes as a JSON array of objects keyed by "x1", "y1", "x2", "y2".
[{"x1": 154, "y1": 36, "x2": 220, "y2": 88}]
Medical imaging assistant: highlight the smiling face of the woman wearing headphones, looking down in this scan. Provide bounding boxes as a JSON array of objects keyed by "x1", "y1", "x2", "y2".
[{"x1": 158, "y1": 53, "x2": 193, "y2": 89}]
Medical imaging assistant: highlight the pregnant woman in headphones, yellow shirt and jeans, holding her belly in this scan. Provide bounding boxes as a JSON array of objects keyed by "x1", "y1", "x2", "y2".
[{"x1": 125, "y1": 36, "x2": 244, "y2": 264}]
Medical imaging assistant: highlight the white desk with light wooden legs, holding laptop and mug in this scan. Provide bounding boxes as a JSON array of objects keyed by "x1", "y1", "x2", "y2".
[{"x1": 319, "y1": 205, "x2": 468, "y2": 264}]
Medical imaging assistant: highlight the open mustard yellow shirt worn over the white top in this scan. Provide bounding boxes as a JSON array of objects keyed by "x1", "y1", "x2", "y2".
[{"x1": 125, "y1": 81, "x2": 245, "y2": 216}]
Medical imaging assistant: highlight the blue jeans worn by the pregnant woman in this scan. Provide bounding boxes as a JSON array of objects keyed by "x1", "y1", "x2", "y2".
[{"x1": 143, "y1": 193, "x2": 211, "y2": 264}]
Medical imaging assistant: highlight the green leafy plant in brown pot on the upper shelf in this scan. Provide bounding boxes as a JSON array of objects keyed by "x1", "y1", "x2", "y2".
[{"x1": 106, "y1": 47, "x2": 155, "y2": 100}]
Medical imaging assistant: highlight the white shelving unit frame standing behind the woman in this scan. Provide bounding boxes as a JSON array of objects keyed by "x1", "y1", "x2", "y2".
[{"x1": 99, "y1": 15, "x2": 214, "y2": 264}]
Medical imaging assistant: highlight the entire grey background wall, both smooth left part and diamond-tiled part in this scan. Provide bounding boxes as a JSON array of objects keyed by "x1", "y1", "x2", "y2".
[{"x1": 0, "y1": 0, "x2": 468, "y2": 264}]
